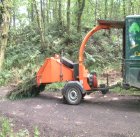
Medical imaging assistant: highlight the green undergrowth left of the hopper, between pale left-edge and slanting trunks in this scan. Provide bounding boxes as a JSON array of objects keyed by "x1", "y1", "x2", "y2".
[{"x1": 0, "y1": 26, "x2": 46, "y2": 85}]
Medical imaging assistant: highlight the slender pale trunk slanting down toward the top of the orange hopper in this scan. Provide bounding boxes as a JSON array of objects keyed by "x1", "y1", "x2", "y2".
[{"x1": 33, "y1": 0, "x2": 47, "y2": 52}]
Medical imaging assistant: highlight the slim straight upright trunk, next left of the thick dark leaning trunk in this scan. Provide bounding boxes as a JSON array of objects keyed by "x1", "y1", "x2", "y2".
[{"x1": 67, "y1": 0, "x2": 70, "y2": 35}]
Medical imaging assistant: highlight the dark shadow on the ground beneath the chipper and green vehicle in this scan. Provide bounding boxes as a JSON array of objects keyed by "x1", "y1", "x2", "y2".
[{"x1": 37, "y1": 93, "x2": 140, "y2": 112}]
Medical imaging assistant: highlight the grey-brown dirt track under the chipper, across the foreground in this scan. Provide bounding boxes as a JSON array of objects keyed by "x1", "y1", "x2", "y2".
[{"x1": 0, "y1": 87, "x2": 140, "y2": 137}]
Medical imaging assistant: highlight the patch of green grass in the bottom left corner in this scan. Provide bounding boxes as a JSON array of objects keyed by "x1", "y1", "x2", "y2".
[{"x1": 0, "y1": 117, "x2": 40, "y2": 137}]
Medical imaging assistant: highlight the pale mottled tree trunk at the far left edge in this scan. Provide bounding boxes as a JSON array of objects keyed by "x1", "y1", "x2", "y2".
[{"x1": 0, "y1": 0, "x2": 10, "y2": 71}]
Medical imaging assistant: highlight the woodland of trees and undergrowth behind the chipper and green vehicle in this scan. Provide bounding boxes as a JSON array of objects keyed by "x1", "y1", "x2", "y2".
[{"x1": 0, "y1": 0, "x2": 140, "y2": 85}]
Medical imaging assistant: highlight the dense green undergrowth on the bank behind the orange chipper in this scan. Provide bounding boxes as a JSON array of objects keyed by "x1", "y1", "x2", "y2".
[{"x1": 0, "y1": 22, "x2": 121, "y2": 85}]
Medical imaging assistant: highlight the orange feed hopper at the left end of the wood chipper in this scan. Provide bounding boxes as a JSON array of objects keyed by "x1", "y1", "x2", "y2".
[{"x1": 37, "y1": 55, "x2": 73, "y2": 85}]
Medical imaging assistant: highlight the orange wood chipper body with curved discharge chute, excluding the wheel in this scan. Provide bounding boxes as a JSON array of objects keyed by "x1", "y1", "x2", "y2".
[{"x1": 36, "y1": 25, "x2": 109, "y2": 91}]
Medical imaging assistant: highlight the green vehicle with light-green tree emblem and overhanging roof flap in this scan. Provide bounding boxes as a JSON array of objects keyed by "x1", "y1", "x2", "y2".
[{"x1": 98, "y1": 15, "x2": 140, "y2": 88}]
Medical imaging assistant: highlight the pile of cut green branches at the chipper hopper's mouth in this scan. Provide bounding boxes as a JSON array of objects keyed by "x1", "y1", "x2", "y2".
[{"x1": 7, "y1": 77, "x2": 45, "y2": 100}]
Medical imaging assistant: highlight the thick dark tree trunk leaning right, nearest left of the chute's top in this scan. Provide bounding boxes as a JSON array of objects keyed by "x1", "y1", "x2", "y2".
[{"x1": 77, "y1": 0, "x2": 85, "y2": 33}]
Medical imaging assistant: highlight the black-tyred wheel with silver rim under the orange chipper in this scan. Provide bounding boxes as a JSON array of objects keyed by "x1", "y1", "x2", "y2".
[{"x1": 64, "y1": 85, "x2": 82, "y2": 105}]
